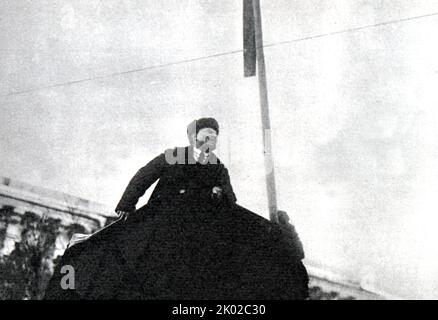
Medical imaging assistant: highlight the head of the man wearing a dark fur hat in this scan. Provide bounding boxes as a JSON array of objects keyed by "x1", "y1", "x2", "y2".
[{"x1": 187, "y1": 118, "x2": 219, "y2": 152}]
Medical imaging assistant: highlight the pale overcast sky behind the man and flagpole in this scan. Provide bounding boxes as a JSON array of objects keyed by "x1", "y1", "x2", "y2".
[{"x1": 0, "y1": 0, "x2": 438, "y2": 297}]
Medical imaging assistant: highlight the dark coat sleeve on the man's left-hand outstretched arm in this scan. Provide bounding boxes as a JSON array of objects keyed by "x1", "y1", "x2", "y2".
[{"x1": 115, "y1": 153, "x2": 166, "y2": 212}]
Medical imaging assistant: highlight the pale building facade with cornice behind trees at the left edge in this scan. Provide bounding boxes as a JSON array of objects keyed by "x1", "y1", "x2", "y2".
[{"x1": 0, "y1": 177, "x2": 116, "y2": 257}]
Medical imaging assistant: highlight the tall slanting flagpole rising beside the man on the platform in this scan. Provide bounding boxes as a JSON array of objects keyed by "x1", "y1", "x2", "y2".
[{"x1": 252, "y1": 0, "x2": 278, "y2": 222}]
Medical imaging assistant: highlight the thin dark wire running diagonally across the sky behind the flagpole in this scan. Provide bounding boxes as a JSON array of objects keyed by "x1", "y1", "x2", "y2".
[{"x1": 0, "y1": 12, "x2": 438, "y2": 97}]
